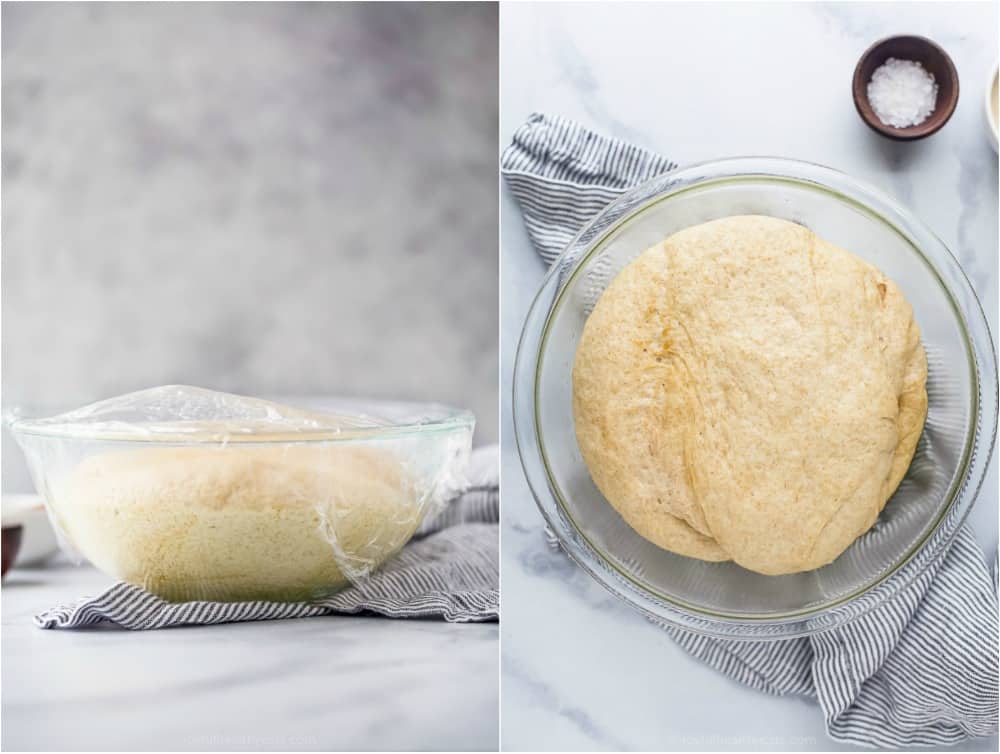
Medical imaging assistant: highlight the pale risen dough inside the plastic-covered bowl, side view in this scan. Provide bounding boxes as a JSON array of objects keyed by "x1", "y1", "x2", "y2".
[{"x1": 52, "y1": 445, "x2": 423, "y2": 601}]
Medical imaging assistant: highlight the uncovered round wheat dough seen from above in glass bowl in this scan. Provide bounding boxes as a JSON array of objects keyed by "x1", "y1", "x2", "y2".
[{"x1": 573, "y1": 216, "x2": 927, "y2": 574}]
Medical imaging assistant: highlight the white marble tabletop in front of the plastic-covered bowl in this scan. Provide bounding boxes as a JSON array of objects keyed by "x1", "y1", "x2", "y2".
[{"x1": 2, "y1": 565, "x2": 499, "y2": 751}]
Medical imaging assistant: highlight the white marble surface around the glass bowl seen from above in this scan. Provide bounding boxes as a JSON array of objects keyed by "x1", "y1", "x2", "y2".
[{"x1": 500, "y1": 3, "x2": 998, "y2": 751}]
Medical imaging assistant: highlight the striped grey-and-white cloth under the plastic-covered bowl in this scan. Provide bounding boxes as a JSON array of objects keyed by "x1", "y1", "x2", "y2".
[{"x1": 35, "y1": 445, "x2": 500, "y2": 630}]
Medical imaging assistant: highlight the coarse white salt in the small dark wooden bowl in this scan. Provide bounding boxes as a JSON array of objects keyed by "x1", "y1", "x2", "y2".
[{"x1": 868, "y1": 58, "x2": 938, "y2": 128}]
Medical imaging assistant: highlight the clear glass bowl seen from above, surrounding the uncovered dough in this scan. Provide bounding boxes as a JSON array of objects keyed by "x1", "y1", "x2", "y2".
[{"x1": 514, "y1": 158, "x2": 997, "y2": 639}]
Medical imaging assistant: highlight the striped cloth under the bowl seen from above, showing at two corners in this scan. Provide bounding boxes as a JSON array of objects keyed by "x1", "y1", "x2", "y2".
[{"x1": 501, "y1": 114, "x2": 998, "y2": 748}]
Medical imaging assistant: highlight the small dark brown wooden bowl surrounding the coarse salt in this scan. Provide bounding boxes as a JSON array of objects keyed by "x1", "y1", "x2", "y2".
[{"x1": 852, "y1": 35, "x2": 958, "y2": 141}]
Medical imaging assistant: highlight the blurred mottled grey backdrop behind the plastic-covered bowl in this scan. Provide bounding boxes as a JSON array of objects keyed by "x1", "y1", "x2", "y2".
[{"x1": 2, "y1": 3, "x2": 498, "y2": 452}]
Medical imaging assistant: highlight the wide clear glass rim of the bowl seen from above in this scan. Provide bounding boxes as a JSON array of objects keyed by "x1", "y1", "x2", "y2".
[{"x1": 512, "y1": 157, "x2": 997, "y2": 639}]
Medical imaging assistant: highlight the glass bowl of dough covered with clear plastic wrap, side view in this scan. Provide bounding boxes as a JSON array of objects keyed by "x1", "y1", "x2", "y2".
[{"x1": 9, "y1": 386, "x2": 474, "y2": 601}]
